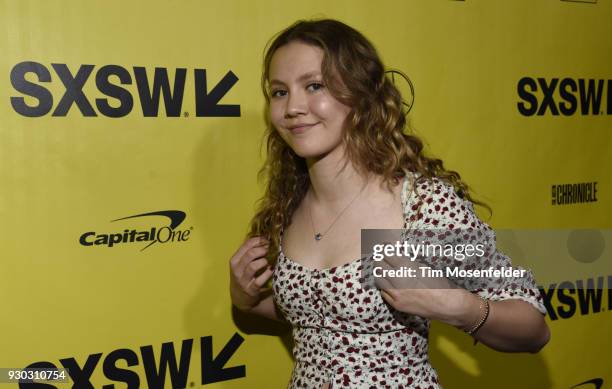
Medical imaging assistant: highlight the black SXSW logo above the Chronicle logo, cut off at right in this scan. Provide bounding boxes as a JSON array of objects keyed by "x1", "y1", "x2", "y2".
[{"x1": 516, "y1": 77, "x2": 612, "y2": 116}]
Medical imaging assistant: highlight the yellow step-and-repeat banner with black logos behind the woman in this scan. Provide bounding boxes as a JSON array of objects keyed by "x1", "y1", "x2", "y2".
[{"x1": 0, "y1": 0, "x2": 612, "y2": 388}]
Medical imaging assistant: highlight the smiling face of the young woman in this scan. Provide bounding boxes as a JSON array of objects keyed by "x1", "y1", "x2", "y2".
[{"x1": 269, "y1": 41, "x2": 350, "y2": 158}]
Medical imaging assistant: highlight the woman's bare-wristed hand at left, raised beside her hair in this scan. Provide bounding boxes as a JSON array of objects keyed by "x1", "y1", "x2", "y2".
[{"x1": 230, "y1": 236, "x2": 273, "y2": 311}]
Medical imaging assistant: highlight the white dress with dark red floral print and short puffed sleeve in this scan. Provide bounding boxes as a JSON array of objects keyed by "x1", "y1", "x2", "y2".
[{"x1": 272, "y1": 176, "x2": 546, "y2": 389}]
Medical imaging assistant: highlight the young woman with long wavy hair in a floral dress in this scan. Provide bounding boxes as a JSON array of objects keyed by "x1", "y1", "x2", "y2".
[{"x1": 230, "y1": 20, "x2": 549, "y2": 388}]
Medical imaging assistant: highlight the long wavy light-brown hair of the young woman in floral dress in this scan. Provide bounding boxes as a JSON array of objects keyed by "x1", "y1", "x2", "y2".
[{"x1": 247, "y1": 19, "x2": 490, "y2": 263}]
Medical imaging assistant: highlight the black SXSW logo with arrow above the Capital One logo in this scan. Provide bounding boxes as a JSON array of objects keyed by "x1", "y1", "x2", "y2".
[{"x1": 10, "y1": 61, "x2": 240, "y2": 118}]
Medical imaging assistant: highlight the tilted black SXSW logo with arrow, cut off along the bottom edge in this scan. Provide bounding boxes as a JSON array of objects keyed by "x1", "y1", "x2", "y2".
[{"x1": 19, "y1": 333, "x2": 246, "y2": 389}]
